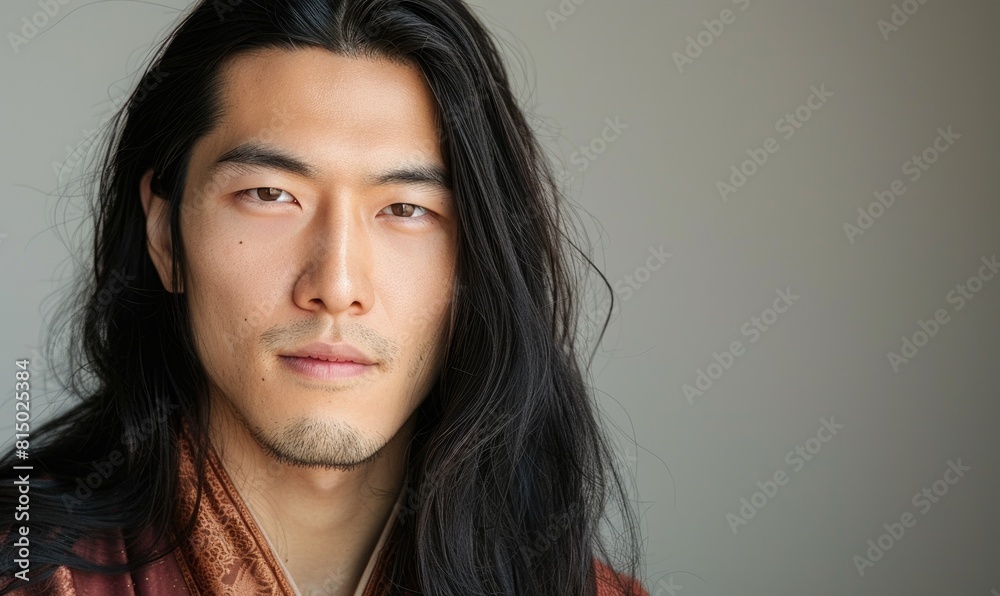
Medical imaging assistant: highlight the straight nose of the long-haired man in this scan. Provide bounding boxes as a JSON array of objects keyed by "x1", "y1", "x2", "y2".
[{"x1": 294, "y1": 201, "x2": 374, "y2": 316}]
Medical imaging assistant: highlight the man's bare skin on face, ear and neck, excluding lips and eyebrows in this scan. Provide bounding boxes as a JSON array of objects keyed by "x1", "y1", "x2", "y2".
[{"x1": 140, "y1": 48, "x2": 457, "y2": 595}]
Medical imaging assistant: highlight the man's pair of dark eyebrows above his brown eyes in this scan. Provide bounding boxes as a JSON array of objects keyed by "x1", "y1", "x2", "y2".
[{"x1": 208, "y1": 143, "x2": 451, "y2": 190}]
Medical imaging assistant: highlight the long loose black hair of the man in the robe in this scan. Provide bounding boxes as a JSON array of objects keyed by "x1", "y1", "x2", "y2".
[{"x1": 0, "y1": 0, "x2": 640, "y2": 596}]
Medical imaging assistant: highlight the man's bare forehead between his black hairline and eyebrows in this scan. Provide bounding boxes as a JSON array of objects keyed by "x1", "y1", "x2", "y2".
[{"x1": 192, "y1": 48, "x2": 442, "y2": 175}]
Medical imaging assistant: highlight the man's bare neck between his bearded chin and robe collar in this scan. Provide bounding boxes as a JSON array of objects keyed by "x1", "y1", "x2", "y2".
[{"x1": 209, "y1": 407, "x2": 416, "y2": 596}]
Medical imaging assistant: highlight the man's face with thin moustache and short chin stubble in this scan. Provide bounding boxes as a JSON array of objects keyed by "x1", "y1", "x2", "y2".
[{"x1": 145, "y1": 49, "x2": 457, "y2": 469}]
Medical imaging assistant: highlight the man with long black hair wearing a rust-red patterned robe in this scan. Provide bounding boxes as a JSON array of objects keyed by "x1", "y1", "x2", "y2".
[{"x1": 0, "y1": 0, "x2": 644, "y2": 596}]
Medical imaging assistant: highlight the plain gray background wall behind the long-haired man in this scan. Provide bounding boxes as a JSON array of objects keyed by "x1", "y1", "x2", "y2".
[{"x1": 0, "y1": 0, "x2": 1000, "y2": 596}]
